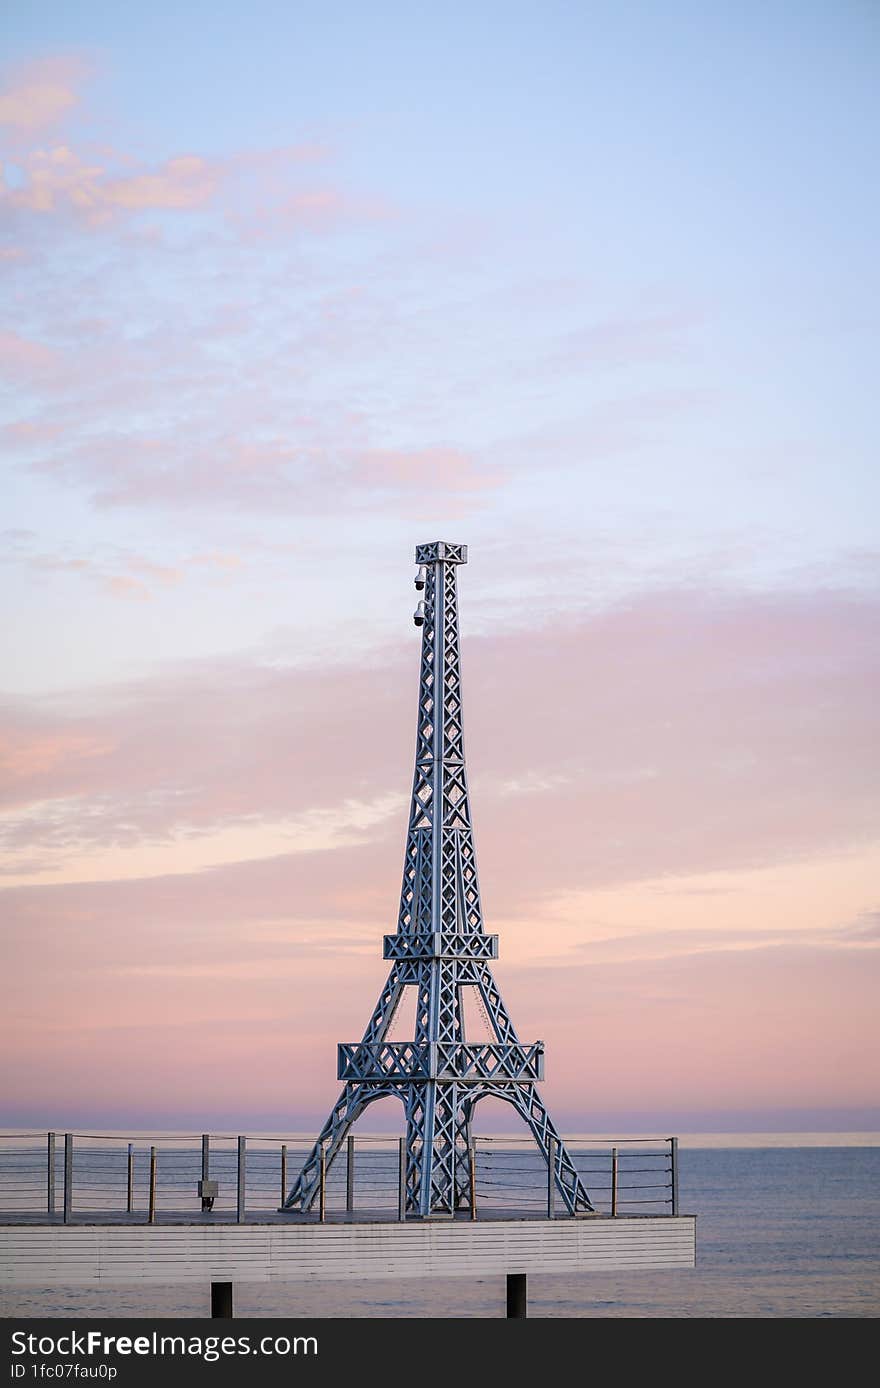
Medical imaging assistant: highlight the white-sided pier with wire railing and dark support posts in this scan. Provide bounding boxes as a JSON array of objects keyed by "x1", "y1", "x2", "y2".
[{"x1": 0, "y1": 1133, "x2": 695, "y2": 1319}]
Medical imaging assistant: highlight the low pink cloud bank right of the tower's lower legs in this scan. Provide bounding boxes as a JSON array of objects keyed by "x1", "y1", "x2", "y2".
[{"x1": 499, "y1": 941, "x2": 880, "y2": 1126}]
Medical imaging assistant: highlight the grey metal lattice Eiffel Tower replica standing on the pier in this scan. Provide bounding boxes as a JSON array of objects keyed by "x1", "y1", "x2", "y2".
[{"x1": 282, "y1": 540, "x2": 594, "y2": 1219}]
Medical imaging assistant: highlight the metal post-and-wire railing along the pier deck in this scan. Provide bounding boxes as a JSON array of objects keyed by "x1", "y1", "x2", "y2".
[{"x1": 0, "y1": 1131, "x2": 679, "y2": 1223}]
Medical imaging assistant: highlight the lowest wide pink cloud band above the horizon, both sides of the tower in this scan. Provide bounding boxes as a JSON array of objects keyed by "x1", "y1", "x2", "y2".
[{"x1": 1, "y1": 849, "x2": 880, "y2": 1131}]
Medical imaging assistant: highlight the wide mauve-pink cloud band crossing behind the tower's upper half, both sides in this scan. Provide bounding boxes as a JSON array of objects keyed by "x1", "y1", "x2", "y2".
[{"x1": 3, "y1": 580, "x2": 880, "y2": 893}]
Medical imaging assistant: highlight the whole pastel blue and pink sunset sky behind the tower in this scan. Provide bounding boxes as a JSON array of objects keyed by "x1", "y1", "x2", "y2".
[{"x1": 0, "y1": 0, "x2": 880, "y2": 1133}]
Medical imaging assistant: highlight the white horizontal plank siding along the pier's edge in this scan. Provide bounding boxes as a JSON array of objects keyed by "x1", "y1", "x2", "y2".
[{"x1": 0, "y1": 1216, "x2": 695, "y2": 1287}]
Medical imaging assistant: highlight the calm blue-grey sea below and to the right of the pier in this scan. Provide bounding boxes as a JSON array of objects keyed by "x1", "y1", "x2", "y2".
[{"x1": 0, "y1": 1146, "x2": 880, "y2": 1317}]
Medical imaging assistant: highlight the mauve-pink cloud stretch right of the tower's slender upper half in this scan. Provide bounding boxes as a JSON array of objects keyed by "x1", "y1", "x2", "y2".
[{"x1": 468, "y1": 593, "x2": 880, "y2": 898}]
